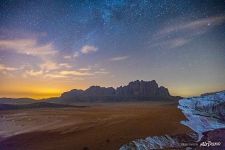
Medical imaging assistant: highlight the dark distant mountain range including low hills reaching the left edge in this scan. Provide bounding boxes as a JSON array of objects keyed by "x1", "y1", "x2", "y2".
[{"x1": 0, "y1": 80, "x2": 181, "y2": 105}]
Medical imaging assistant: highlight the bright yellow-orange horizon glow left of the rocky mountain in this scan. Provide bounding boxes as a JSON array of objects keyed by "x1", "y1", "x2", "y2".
[{"x1": 0, "y1": 75, "x2": 88, "y2": 99}]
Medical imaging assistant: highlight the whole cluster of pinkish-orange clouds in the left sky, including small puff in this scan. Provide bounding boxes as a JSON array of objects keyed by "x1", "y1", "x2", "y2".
[{"x1": 0, "y1": 38, "x2": 106, "y2": 79}]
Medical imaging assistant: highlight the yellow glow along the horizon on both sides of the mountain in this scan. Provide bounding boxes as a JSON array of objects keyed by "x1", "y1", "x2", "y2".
[{"x1": 0, "y1": 75, "x2": 224, "y2": 99}]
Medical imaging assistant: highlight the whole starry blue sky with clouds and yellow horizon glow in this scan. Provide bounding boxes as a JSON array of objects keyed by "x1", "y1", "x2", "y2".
[{"x1": 0, "y1": 0, "x2": 225, "y2": 98}]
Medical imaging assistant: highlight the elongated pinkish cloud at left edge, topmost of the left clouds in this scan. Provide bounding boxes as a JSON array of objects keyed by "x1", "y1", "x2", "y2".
[{"x1": 0, "y1": 39, "x2": 57, "y2": 57}]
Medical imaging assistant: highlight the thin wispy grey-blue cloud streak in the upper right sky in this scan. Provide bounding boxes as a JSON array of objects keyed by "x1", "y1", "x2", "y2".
[{"x1": 149, "y1": 16, "x2": 225, "y2": 49}]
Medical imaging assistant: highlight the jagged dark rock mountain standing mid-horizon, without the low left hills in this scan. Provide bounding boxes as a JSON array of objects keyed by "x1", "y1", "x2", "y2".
[{"x1": 57, "y1": 80, "x2": 172, "y2": 103}]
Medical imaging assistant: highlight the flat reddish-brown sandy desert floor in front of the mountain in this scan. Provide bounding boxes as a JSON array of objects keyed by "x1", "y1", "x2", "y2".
[{"x1": 0, "y1": 102, "x2": 189, "y2": 150}]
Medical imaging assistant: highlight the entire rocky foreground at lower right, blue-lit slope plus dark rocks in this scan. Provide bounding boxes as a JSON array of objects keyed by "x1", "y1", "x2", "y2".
[{"x1": 120, "y1": 91, "x2": 225, "y2": 150}]
